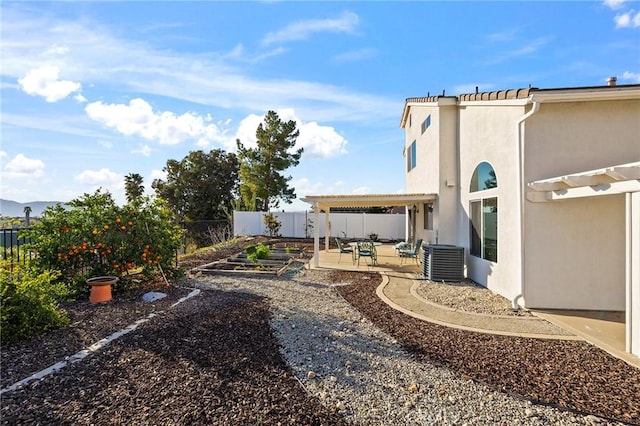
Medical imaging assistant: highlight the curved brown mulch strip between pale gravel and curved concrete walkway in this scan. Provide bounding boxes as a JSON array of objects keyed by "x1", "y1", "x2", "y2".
[{"x1": 335, "y1": 271, "x2": 640, "y2": 424}]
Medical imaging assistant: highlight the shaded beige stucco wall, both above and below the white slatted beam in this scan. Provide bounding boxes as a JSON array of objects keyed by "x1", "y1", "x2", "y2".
[{"x1": 525, "y1": 100, "x2": 640, "y2": 310}]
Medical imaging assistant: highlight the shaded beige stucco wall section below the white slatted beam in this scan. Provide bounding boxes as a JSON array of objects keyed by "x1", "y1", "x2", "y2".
[{"x1": 524, "y1": 195, "x2": 625, "y2": 311}]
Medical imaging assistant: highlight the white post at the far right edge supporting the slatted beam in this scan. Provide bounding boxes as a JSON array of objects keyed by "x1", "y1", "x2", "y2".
[{"x1": 625, "y1": 192, "x2": 640, "y2": 356}]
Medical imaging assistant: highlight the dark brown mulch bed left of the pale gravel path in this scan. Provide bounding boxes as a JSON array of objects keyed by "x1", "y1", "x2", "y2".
[{"x1": 1, "y1": 291, "x2": 344, "y2": 425}]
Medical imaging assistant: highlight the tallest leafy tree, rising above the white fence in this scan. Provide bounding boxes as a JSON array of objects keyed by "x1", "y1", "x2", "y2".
[{"x1": 236, "y1": 111, "x2": 303, "y2": 211}]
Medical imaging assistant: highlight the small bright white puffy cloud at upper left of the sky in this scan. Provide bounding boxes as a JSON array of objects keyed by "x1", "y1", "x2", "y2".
[{"x1": 18, "y1": 65, "x2": 82, "y2": 102}]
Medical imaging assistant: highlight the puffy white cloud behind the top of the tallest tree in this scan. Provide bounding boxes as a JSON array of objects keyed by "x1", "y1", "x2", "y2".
[{"x1": 228, "y1": 108, "x2": 348, "y2": 158}]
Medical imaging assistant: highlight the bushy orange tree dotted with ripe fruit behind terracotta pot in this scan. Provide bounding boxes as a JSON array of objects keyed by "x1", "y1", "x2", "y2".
[{"x1": 25, "y1": 189, "x2": 182, "y2": 293}]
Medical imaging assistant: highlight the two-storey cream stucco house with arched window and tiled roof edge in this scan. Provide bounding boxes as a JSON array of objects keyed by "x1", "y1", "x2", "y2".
[{"x1": 401, "y1": 79, "x2": 640, "y2": 356}]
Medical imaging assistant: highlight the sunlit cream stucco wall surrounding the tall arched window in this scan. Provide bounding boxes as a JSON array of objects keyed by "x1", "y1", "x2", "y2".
[{"x1": 458, "y1": 102, "x2": 525, "y2": 299}]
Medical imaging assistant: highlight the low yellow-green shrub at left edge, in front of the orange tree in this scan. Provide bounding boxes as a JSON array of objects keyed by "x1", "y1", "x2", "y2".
[{"x1": 0, "y1": 265, "x2": 69, "y2": 344}]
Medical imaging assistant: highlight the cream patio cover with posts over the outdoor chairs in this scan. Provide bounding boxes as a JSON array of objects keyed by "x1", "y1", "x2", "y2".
[{"x1": 302, "y1": 194, "x2": 438, "y2": 268}]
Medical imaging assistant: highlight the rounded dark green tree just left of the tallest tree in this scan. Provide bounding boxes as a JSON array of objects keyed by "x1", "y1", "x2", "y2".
[{"x1": 151, "y1": 149, "x2": 238, "y2": 221}]
